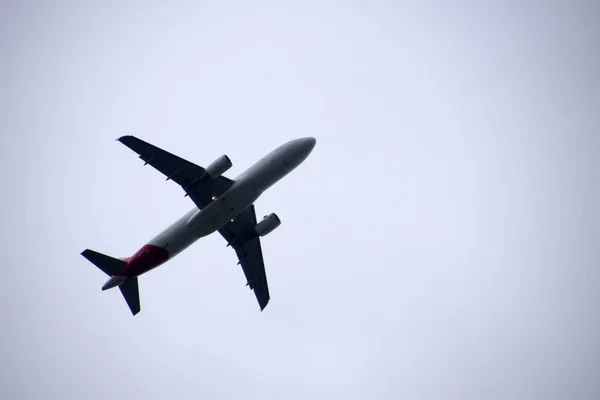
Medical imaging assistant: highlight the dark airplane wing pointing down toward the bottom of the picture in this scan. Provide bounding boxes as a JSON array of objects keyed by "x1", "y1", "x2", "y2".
[{"x1": 219, "y1": 205, "x2": 270, "y2": 311}]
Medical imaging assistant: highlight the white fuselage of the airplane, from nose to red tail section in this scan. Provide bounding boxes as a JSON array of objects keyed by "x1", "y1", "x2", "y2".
[{"x1": 148, "y1": 138, "x2": 316, "y2": 259}]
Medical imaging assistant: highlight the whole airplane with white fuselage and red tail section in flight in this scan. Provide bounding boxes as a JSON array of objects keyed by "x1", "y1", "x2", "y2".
[{"x1": 81, "y1": 136, "x2": 317, "y2": 315}]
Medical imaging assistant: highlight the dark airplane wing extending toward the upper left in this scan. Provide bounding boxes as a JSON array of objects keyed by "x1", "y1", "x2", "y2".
[{"x1": 118, "y1": 136, "x2": 233, "y2": 209}]
